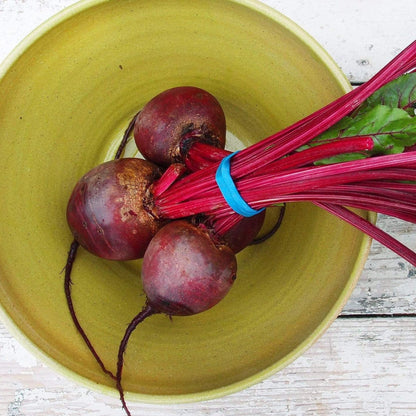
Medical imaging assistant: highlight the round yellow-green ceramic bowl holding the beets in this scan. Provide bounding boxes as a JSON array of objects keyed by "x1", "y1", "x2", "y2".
[{"x1": 0, "y1": 0, "x2": 370, "y2": 403}]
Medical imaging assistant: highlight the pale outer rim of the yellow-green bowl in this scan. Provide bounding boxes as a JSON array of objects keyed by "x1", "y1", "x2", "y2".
[{"x1": 0, "y1": 0, "x2": 370, "y2": 404}]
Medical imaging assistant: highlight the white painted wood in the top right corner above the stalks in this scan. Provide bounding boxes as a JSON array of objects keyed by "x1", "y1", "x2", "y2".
[{"x1": 263, "y1": 0, "x2": 416, "y2": 81}]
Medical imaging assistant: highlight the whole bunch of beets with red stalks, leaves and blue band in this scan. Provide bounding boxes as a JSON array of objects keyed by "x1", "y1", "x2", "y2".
[{"x1": 65, "y1": 41, "x2": 416, "y2": 414}]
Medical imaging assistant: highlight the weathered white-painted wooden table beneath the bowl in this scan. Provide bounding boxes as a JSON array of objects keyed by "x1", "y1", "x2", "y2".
[{"x1": 0, "y1": 0, "x2": 416, "y2": 416}]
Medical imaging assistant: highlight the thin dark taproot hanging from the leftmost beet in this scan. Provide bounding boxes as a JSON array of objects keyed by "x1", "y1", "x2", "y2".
[{"x1": 64, "y1": 240, "x2": 116, "y2": 379}]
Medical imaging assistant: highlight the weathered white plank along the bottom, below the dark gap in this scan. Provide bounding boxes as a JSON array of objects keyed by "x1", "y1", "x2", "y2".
[{"x1": 0, "y1": 318, "x2": 416, "y2": 416}]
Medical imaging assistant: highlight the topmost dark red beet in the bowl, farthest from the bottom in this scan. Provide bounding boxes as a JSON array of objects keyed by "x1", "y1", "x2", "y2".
[{"x1": 134, "y1": 86, "x2": 226, "y2": 166}]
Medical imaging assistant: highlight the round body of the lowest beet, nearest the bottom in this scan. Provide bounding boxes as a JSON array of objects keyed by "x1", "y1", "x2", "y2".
[{"x1": 142, "y1": 220, "x2": 237, "y2": 315}]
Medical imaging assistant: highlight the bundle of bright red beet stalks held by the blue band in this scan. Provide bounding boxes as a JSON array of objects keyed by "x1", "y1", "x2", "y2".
[{"x1": 154, "y1": 41, "x2": 416, "y2": 265}]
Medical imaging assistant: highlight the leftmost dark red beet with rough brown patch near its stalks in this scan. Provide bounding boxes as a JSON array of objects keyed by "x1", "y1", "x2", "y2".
[{"x1": 67, "y1": 158, "x2": 163, "y2": 260}]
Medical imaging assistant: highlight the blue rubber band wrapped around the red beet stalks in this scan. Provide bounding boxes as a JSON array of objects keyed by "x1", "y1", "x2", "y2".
[{"x1": 215, "y1": 151, "x2": 264, "y2": 217}]
